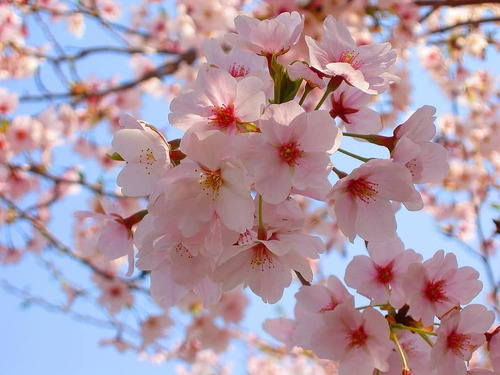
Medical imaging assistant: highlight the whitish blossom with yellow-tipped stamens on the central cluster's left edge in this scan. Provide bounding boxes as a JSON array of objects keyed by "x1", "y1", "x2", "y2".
[{"x1": 112, "y1": 115, "x2": 171, "y2": 197}]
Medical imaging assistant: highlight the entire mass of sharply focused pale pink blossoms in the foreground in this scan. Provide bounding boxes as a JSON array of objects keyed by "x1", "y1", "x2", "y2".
[{"x1": 92, "y1": 12, "x2": 495, "y2": 374}]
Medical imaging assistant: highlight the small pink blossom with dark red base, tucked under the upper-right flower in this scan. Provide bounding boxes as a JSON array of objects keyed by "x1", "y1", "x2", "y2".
[{"x1": 329, "y1": 82, "x2": 382, "y2": 134}]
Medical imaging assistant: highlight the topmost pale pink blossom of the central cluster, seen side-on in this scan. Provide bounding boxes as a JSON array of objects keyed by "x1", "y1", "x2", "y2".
[{"x1": 226, "y1": 12, "x2": 304, "y2": 56}]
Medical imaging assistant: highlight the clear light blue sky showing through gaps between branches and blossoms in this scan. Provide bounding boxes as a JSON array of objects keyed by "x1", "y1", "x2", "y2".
[{"x1": 0, "y1": 3, "x2": 500, "y2": 375}]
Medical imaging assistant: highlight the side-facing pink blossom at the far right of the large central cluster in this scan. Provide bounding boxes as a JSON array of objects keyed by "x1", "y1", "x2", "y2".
[{"x1": 391, "y1": 105, "x2": 449, "y2": 184}]
